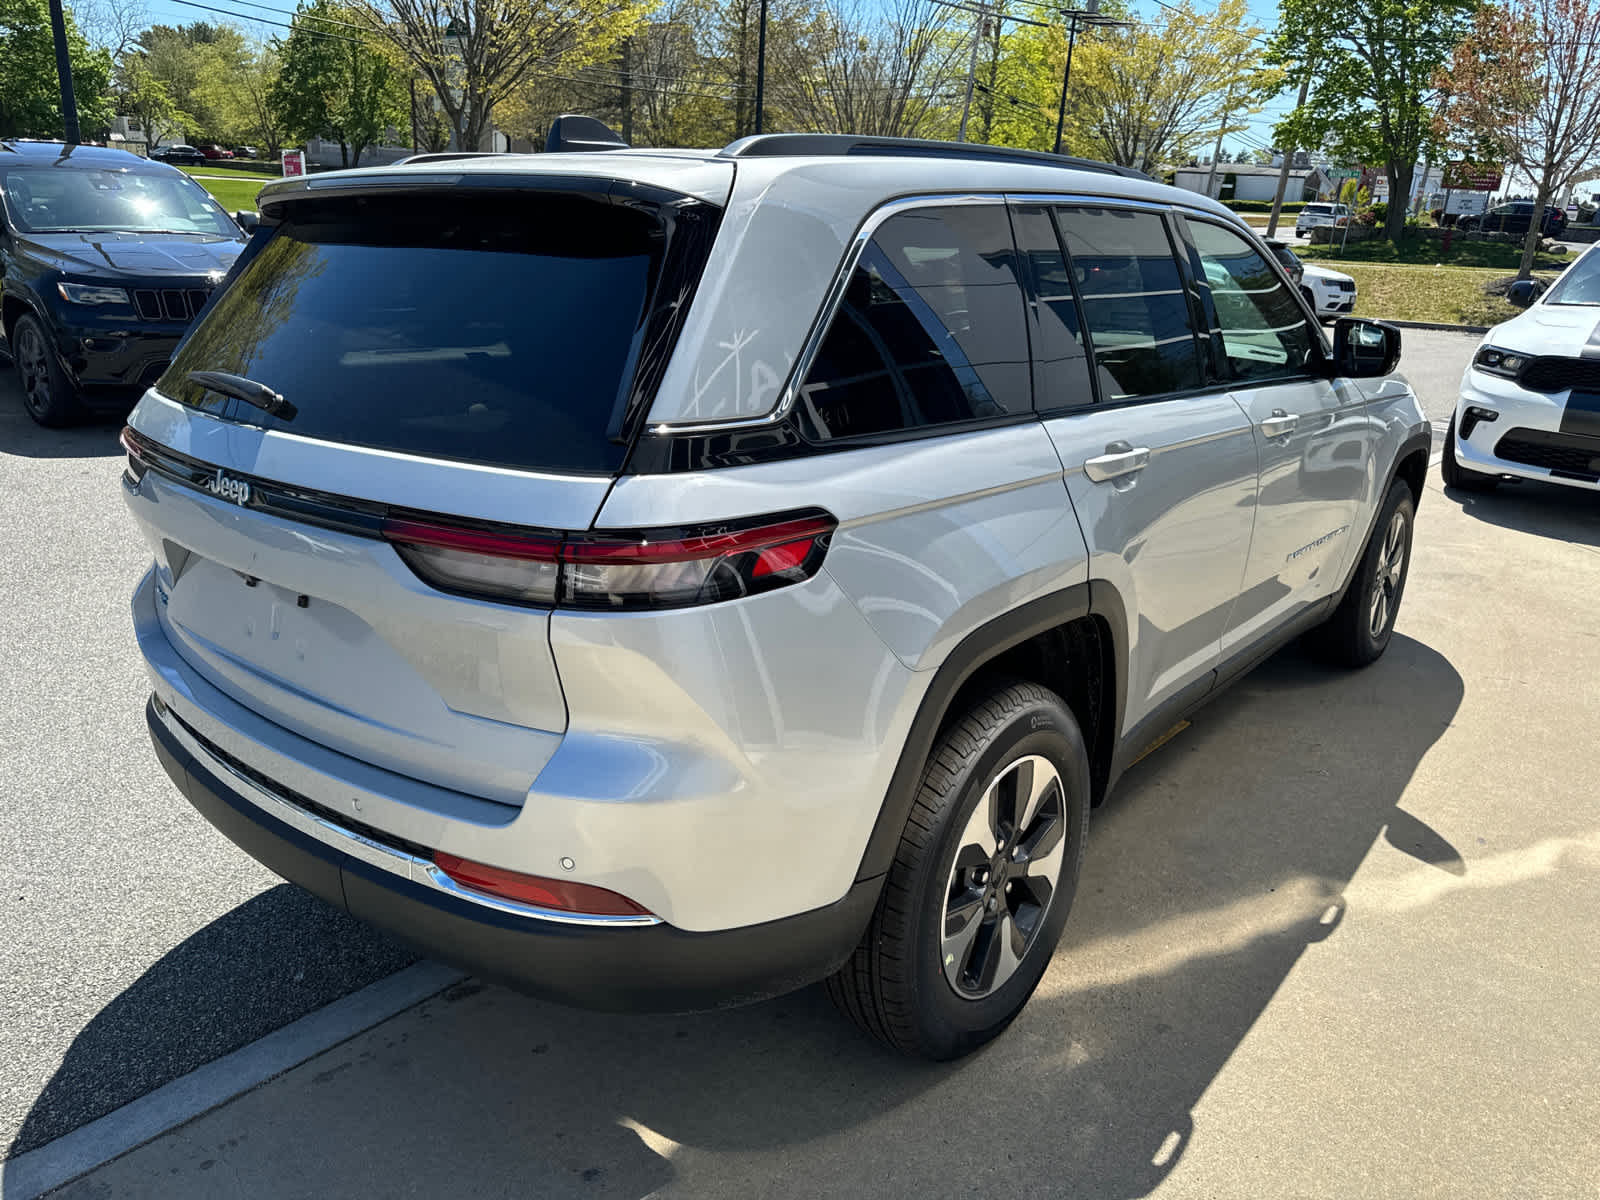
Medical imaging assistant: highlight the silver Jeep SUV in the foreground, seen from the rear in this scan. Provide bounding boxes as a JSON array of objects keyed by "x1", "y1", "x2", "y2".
[{"x1": 123, "y1": 136, "x2": 1429, "y2": 1058}]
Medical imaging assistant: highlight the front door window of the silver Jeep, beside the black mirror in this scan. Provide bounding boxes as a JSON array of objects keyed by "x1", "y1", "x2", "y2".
[{"x1": 1189, "y1": 221, "x2": 1317, "y2": 379}]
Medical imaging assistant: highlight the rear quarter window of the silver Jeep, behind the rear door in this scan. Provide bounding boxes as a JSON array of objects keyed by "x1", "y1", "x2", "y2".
[{"x1": 800, "y1": 205, "x2": 1034, "y2": 438}]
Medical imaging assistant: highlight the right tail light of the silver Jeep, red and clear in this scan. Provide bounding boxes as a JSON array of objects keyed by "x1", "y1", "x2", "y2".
[{"x1": 384, "y1": 512, "x2": 837, "y2": 610}]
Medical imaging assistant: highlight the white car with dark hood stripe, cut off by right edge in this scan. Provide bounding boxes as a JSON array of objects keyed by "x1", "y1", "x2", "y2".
[{"x1": 1440, "y1": 248, "x2": 1600, "y2": 491}]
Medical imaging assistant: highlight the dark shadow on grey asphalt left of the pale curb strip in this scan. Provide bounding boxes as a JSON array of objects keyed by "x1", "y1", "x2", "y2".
[{"x1": 0, "y1": 883, "x2": 416, "y2": 1158}]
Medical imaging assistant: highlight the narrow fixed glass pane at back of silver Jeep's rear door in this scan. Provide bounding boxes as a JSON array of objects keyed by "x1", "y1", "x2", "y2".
[{"x1": 1011, "y1": 205, "x2": 1094, "y2": 413}]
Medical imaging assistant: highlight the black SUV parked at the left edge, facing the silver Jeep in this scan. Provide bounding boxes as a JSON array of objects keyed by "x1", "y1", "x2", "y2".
[{"x1": 0, "y1": 141, "x2": 246, "y2": 426}]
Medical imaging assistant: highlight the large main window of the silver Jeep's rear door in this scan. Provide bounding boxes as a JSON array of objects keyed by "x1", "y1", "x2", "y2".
[{"x1": 1056, "y1": 208, "x2": 1200, "y2": 400}]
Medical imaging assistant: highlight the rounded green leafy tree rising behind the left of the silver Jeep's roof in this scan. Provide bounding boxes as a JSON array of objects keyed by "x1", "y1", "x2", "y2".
[{"x1": 267, "y1": 0, "x2": 408, "y2": 166}]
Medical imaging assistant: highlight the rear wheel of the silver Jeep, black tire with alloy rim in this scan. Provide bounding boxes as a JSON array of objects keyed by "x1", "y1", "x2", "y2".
[{"x1": 827, "y1": 683, "x2": 1090, "y2": 1059}]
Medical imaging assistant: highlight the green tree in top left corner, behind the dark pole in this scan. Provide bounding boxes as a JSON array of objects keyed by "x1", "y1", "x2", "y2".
[{"x1": 0, "y1": 0, "x2": 112, "y2": 138}]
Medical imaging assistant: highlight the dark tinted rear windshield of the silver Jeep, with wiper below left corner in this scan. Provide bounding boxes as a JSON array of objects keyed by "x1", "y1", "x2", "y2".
[{"x1": 158, "y1": 192, "x2": 664, "y2": 474}]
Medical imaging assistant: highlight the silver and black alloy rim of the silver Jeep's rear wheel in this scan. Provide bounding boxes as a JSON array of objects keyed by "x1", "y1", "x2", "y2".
[{"x1": 939, "y1": 754, "x2": 1066, "y2": 1000}]
